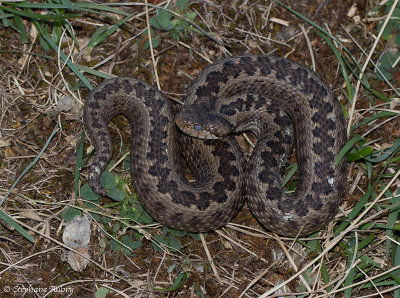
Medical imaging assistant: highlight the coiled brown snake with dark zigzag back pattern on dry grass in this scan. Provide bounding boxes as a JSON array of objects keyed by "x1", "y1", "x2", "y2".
[{"x1": 83, "y1": 55, "x2": 347, "y2": 237}]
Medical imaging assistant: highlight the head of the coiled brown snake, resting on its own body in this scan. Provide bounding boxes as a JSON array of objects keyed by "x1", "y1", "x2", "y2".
[{"x1": 175, "y1": 104, "x2": 234, "y2": 139}]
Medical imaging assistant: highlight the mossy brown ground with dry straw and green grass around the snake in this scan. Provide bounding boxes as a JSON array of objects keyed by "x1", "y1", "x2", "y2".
[{"x1": 0, "y1": 0, "x2": 400, "y2": 297}]
